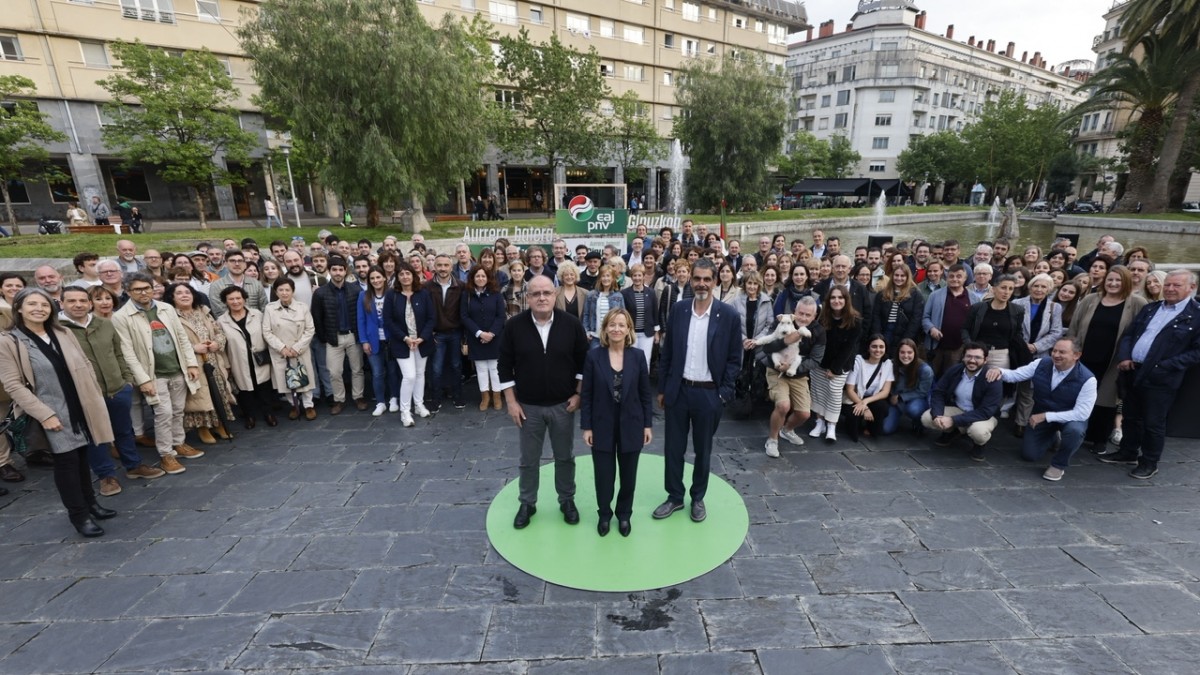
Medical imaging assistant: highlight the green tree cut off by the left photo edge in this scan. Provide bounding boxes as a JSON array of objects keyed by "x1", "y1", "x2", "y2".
[{"x1": 0, "y1": 74, "x2": 67, "y2": 234}]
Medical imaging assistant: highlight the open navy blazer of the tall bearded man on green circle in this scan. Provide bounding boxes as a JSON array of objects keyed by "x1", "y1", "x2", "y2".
[{"x1": 659, "y1": 300, "x2": 742, "y2": 405}]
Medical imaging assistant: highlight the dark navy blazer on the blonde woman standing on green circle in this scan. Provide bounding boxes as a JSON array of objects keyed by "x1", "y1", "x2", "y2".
[{"x1": 580, "y1": 347, "x2": 654, "y2": 453}]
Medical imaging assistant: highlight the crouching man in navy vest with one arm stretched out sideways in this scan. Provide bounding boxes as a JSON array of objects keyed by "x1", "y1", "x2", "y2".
[{"x1": 988, "y1": 338, "x2": 1096, "y2": 480}]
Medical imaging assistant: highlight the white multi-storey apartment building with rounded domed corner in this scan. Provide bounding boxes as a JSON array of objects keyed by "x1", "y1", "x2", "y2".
[{"x1": 787, "y1": 0, "x2": 1086, "y2": 198}]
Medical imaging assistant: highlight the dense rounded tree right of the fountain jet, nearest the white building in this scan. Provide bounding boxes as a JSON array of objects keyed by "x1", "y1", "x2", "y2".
[{"x1": 674, "y1": 56, "x2": 787, "y2": 209}]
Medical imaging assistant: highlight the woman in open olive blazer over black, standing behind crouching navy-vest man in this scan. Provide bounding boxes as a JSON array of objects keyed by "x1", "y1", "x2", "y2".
[{"x1": 1067, "y1": 264, "x2": 1147, "y2": 448}]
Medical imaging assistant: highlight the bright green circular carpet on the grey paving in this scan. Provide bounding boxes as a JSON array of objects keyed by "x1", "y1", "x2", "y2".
[{"x1": 487, "y1": 453, "x2": 750, "y2": 592}]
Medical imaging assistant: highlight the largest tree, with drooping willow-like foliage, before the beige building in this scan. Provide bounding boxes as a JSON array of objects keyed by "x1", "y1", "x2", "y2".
[{"x1": 239, "y1": 0, "x2": 493, "y2": 227}]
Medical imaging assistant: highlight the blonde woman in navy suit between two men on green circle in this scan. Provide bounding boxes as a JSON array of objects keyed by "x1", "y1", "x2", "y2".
[{"x1": 580, "y1": 309, "x2": 654, "y2": 537}]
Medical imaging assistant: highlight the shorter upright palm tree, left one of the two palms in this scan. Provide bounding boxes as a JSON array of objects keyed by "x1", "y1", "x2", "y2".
[{"x1": 1066, "y1": 26, "x2": 1200, "y2": 211}]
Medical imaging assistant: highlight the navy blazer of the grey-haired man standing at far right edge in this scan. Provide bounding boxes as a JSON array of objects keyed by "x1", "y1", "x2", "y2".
[{"x1": 1117, "y1": 298, "x2": 1200, "y2": 389}]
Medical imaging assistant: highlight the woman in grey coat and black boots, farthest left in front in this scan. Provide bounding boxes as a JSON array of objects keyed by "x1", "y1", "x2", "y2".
[{"x1": 0, "y1": 288, "x2": 116, "y2": 537}]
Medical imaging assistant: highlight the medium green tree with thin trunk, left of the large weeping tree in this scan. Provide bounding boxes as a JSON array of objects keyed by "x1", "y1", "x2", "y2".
[{"x1": 97, "y1": 41, "x2": 257, "y2": 229}]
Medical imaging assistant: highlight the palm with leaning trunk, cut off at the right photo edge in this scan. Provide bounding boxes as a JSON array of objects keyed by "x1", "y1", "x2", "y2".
[{"x1": 1123, "y1": 0, "x2": 1200, "y2": 211}]
